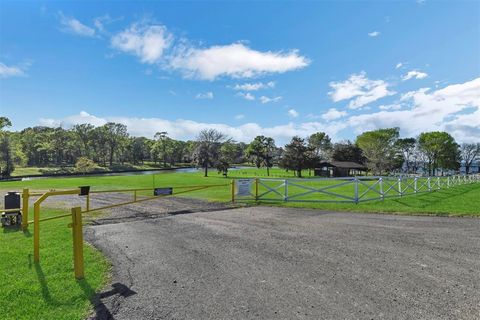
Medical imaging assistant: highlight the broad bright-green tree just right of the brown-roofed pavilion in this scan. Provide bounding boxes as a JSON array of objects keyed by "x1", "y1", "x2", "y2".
[{"x1": 356, "y1": 128, "x2": 399, "y2": 175}]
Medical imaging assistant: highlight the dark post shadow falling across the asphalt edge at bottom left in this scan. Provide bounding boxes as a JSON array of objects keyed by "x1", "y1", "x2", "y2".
[{"x1": 77, "y1": 279, "x2": 137, "y2": 320}]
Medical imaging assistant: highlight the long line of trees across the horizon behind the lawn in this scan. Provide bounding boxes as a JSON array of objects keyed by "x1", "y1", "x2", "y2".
[{"x1": 0, "y1": 117, "x2": 480, "y2": 177}]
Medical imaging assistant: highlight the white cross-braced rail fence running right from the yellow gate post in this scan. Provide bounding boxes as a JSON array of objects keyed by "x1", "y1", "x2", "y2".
[{"x1": 236, "y1": 174, "x2": 480, "y2": 203}]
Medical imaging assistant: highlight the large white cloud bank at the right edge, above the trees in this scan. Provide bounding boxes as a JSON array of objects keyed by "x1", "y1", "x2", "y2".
[{"x1": 347, "y1": 78, "x2": 480, "y2": 142}]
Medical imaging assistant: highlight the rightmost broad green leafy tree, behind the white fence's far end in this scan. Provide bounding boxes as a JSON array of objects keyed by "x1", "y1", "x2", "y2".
[{"x1": 418, "y1": 131, "x2": 460, "y2": 175}]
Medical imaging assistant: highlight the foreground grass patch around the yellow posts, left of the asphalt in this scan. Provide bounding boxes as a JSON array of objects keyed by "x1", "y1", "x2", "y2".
[{"x1": 0, "y1": 210, "x2": 110, "y2": 319}]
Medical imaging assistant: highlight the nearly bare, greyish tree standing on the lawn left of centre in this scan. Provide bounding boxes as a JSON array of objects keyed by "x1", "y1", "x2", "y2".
[{"x1": 193, "y1": 129, "x2": 226, "y2": 177}]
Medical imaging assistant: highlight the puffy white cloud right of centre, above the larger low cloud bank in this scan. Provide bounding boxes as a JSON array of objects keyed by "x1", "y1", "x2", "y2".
[{"x1": 328, "y1": 71, "x2": 395, "y2": 109}]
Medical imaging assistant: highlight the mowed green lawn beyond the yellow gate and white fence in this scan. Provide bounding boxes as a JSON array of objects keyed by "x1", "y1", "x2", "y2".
[{"x1": 0, "y1": 168, "x2": 480, "y2": 216}]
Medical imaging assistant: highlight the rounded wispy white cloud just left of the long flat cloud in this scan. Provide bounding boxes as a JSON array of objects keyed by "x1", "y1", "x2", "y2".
[{"x1": 110, "y1": 23, "x2": 173, "y2": 64}]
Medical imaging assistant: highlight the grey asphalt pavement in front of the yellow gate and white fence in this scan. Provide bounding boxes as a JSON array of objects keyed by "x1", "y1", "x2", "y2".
[{"x1": 86, "y1": 207, "x2": 480, "y2": 319}]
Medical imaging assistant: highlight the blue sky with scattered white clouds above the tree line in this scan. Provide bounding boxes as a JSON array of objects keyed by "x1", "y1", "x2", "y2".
[{"x1": 0, "y1": 0, "x2": 480, "y2": 144}]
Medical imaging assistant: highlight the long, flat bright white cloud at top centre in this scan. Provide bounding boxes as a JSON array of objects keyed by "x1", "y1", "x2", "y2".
[{"x1": 169, "y1": 43, "x2": 310, "y2": 80}]
